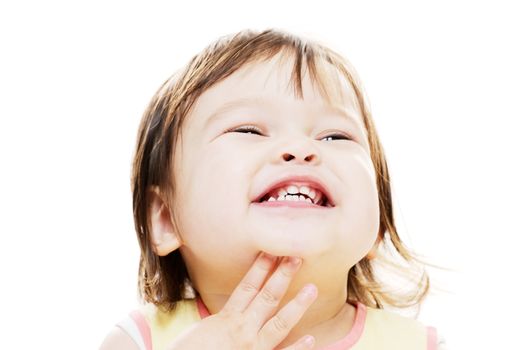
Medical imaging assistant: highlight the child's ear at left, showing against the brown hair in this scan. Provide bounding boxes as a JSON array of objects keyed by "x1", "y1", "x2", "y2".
[{"x1": 149, "y1": 186, "x2": 182, "y2": 256}]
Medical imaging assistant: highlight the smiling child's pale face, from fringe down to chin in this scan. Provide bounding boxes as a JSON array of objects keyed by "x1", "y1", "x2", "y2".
[{"x1": 172, "y1": 59, "x2": 379, "y2": 288}]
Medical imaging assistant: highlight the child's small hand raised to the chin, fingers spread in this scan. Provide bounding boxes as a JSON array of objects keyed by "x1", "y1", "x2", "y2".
[{"x1": 169, "y1": 253, "x2": 317, "y2": 350}]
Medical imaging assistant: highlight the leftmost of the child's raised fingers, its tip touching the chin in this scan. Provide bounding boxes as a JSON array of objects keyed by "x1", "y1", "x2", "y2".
[{"x1": 223, "y1": 252, "x2": 277, "y2": 312}]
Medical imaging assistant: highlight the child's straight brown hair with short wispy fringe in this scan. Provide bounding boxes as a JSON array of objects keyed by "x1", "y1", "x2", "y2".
[{"x1": 131, "y1": 29, "x2": 429, "y2": 310}]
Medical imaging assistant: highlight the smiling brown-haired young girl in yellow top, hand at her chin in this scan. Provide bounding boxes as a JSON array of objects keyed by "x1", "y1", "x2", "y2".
[{"x1": 102, "y1": 30, "x2": 448, "y2": 350}]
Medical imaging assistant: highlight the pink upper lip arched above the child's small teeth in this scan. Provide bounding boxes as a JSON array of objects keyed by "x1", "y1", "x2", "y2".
[{"x1": 252, "y1": 175, "x2": 335, "y2": 207}]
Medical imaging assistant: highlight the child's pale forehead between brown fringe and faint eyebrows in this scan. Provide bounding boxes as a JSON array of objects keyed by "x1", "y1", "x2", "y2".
[{"x1": 192, "y1": 54, "x2": 364, "y2": 130}]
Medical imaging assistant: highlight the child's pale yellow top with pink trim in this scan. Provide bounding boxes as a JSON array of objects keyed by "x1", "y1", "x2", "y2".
[{"x1": 118, "y1": 299, "x2": 438, "y2": 350}]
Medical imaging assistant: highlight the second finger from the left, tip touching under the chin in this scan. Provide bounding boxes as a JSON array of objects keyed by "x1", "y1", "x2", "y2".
[{"x1": 249, "y1": 257, "x2": 301, "y2": 330}]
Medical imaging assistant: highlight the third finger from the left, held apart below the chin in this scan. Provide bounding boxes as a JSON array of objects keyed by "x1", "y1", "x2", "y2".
[{"x1": 259, "y1": 284, "x2": 318, "y2": 349}]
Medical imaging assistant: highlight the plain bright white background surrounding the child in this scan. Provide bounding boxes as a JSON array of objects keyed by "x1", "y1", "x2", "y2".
[{"x1": 0, "y1": 0, "x2": 526, "y2": 349}]
